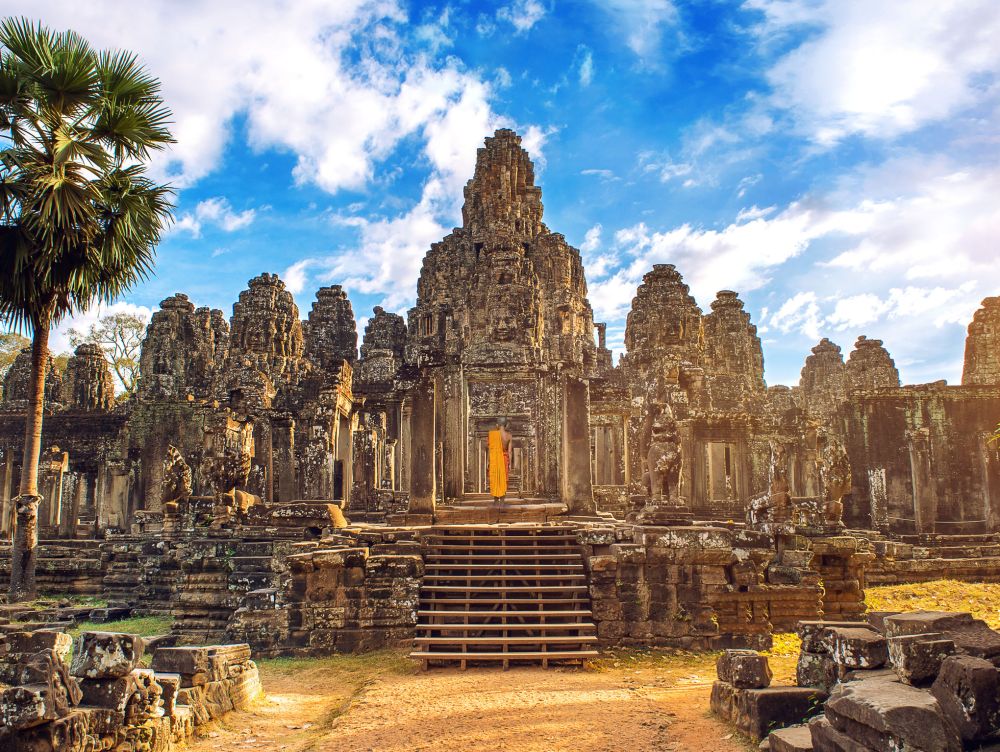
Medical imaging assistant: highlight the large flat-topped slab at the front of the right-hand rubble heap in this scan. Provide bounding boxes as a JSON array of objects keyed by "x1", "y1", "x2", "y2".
[{"x1": 826, "y1": 679, "x2": 962, "y2": 752}]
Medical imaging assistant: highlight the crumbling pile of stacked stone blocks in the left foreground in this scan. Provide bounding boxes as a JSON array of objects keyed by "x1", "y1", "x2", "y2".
[{"x1": 0, "y1": 630, "x2": 262, "y2": 752}]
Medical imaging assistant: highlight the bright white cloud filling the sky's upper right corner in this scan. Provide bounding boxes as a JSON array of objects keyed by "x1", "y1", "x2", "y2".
[{"x1": 746, "y1": 0, "x2": 1000, "y2": 145}]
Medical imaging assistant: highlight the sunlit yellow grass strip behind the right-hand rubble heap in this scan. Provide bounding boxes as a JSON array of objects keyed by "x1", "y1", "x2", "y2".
[{"x1": 865, "y1": 580, "x2": 1000, "y2": 629}]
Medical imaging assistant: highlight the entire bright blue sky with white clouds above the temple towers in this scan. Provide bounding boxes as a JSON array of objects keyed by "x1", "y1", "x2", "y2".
[{"x1": 15, "y1": 0, "x2": 1000, "y2": 384}]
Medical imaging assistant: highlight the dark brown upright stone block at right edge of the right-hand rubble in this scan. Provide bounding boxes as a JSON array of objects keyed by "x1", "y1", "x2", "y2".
[{"x1": 931, "y1": 655, "x2": 1000, "y2": 743}]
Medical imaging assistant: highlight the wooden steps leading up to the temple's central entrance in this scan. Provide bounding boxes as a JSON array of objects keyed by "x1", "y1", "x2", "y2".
[{"x1": 410, "y1": 525, "x2": 598, "y2": 669}]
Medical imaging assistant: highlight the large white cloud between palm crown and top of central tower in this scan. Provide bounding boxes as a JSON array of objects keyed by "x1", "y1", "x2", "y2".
[{"x1": 17, "y1": 0, "x2": 516, "y2": 195}]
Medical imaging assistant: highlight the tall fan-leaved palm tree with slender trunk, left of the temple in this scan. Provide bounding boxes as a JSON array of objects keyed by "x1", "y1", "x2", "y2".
[{"x1": 0, "y1": 19, "x2": 173, "y2": 602}]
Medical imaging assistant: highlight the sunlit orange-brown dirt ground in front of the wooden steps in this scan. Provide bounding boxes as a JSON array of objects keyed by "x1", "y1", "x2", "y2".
[{"x1": 189, "y1": 652, "x2": 782, "y2": 752}]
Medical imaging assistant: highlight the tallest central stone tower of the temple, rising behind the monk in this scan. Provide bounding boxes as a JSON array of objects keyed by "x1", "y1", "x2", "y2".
[{"x1": 407, "y1": 129, "x2": 598, "y2": 513}]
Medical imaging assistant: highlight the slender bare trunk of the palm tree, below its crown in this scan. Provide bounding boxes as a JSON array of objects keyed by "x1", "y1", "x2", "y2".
[{"x1": 7, "y1": 317, "x2": 49, "y2": 603}]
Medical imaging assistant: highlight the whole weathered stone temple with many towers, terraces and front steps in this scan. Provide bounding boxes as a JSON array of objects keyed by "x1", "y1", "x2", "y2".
[{"x1": 0, "y1": 130, "x2": 1000, "y2": 749}]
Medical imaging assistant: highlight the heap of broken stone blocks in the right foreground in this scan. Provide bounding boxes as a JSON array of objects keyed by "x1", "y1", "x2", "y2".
[{"x1": 712, "y1": 611, "x2": 1000, "y2": 752}]
